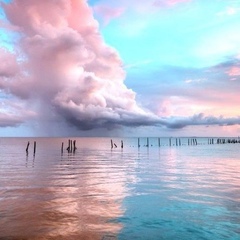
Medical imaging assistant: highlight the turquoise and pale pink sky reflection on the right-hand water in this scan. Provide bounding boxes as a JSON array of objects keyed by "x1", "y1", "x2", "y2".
[{"x1": 116, "y1": 143, "x2": 240, "y2": 240}]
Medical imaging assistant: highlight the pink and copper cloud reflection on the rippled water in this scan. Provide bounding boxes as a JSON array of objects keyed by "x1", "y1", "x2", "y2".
[{"x1": 0, "y1": 138, "x2": 126, "y2": 240}]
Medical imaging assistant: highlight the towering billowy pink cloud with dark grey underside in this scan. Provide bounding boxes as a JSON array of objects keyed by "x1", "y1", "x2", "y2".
[{"x1": 0, "y1": 0, "x2": 154, "y2": 129}]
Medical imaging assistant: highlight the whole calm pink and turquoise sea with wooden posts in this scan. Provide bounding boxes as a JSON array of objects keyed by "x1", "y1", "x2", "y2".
[{"x1": 0, "y1": 137, "x2": 240, "y2": 240}]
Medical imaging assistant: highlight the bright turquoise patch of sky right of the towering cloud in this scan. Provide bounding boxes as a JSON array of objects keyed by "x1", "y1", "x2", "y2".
[{"x1": 92, "y1": 0, "x2": 240, "y2": 65}]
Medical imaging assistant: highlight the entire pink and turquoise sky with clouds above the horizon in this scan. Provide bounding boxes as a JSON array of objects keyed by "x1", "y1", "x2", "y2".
[{"x1": 0, "y1": 0, "x2": 240, "y2": 137}]
